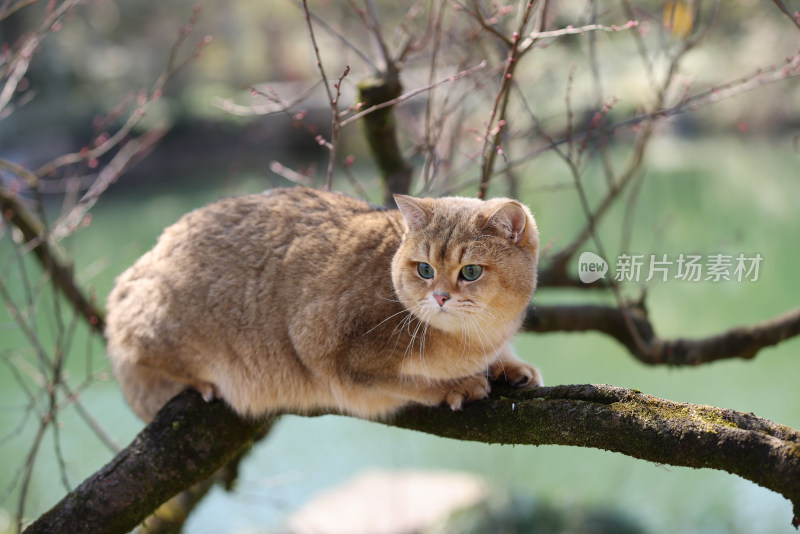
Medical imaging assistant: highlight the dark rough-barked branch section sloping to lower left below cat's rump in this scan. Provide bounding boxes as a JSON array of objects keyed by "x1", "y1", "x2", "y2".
[{"x1": 25, "y1": 391, "x2": 269, "y2": 534}]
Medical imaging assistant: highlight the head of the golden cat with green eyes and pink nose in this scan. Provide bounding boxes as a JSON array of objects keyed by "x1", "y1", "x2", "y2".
[{"x1": 392, "y1": 195, "x2": 539, "y2": 333}]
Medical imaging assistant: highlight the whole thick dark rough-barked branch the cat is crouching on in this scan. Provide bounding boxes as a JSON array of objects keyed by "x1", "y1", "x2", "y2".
[{"x1": 25, "y1": 385, "x2": 800, "y2": 534}]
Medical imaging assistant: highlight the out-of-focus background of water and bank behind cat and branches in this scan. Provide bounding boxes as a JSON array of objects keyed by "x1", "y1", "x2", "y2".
[{"x1": 0, "y1": 0, "x2": 800, "y2": 533}]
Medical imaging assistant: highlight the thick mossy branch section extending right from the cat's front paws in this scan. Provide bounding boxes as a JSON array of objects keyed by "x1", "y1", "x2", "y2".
[{"x1": 390, "y1": 385, "x2": 800, "y2": 527}]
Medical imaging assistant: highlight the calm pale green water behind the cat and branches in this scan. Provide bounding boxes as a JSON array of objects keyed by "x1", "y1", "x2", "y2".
[{"x1": 0, "y1": 138, "x2": 800, "y2": 534}]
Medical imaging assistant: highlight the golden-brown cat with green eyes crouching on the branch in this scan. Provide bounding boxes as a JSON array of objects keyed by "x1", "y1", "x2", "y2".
[{"x1": 106, "y1": 187, "x2": 542, "y2": 421}]
